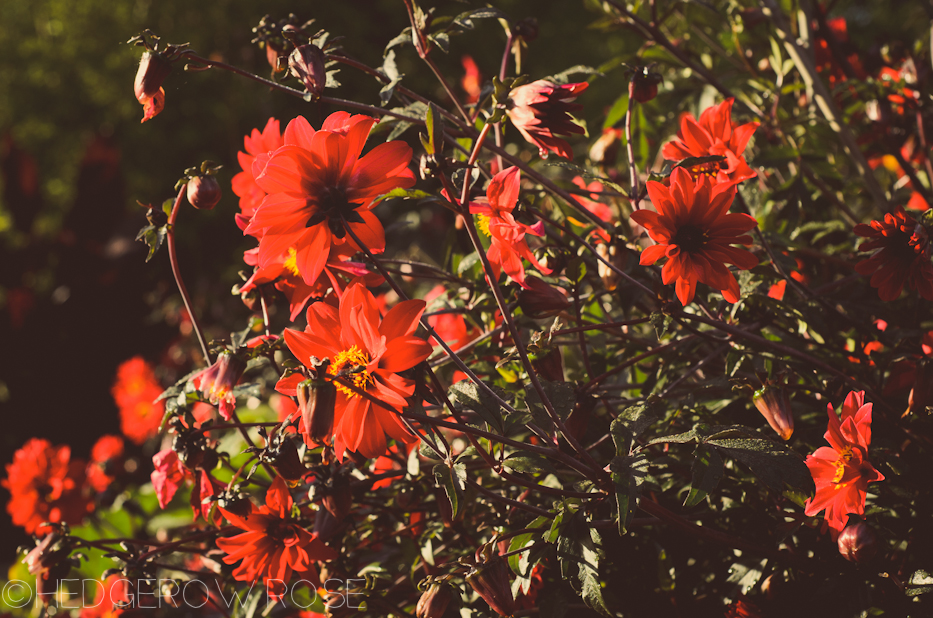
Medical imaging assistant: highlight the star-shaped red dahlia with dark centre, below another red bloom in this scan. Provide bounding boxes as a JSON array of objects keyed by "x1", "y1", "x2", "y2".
[{"x1": 632, "y1": 168, "x2": 758, "y2": 306}]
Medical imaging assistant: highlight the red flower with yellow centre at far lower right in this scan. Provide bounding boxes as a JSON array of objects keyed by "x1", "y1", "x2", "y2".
[{"x1": 805, "y1": 391, "x2": 884, "y2": 540}]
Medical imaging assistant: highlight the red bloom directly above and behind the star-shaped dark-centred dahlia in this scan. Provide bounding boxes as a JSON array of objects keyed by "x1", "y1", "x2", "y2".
[{"x1": 661, "y1": 99, "x2": 759, "y2": 184}]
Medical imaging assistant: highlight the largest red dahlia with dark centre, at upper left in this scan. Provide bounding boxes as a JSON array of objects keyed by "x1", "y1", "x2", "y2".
[{"x1": 245, "y1": 112, "x2": 415, "y2": 285}]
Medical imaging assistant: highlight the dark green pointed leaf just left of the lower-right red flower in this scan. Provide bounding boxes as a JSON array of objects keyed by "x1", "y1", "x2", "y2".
[{"x1": 704, "y1": 438, "x2": 815, "y2": 494}]
